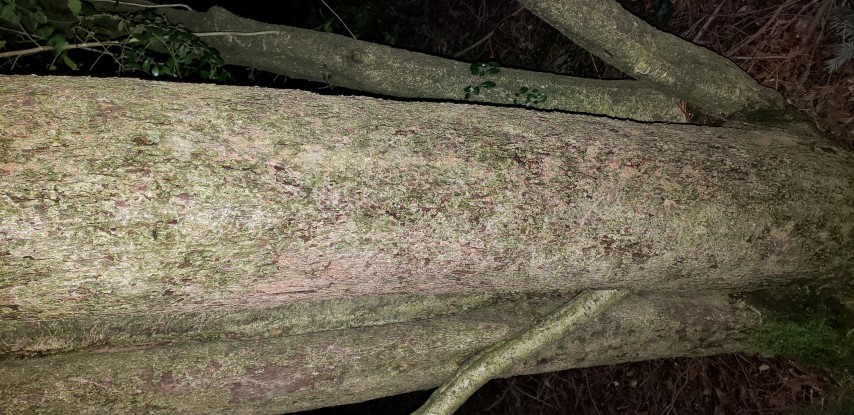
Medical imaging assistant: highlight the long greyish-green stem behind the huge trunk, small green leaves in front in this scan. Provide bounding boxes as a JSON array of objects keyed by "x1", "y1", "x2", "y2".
[{"x1": 155, "y1": 7, "x2": 685, "y2": 122}]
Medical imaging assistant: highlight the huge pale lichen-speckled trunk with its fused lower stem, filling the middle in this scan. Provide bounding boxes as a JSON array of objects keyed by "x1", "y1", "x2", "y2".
[{"x1": 0, "y1": 77, "x2": 854, "y2": 413}]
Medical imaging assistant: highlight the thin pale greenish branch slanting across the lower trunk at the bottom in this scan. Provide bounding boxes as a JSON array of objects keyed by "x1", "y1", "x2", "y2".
[{"x1": 413, "y1": 290, "x2": 628, "y2": 415}]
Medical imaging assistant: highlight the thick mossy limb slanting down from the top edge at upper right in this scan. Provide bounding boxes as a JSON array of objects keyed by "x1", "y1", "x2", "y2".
[{"x1": 519, "y1": 0, "x2": 785, "y2": 118}]
